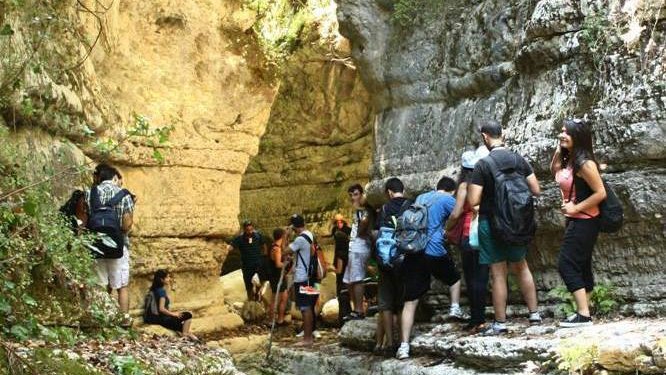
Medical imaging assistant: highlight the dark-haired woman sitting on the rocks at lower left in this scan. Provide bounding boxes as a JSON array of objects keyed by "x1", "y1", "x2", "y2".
[{"x1": 144, "y1": 269, "x2": 197, "y2": 340}]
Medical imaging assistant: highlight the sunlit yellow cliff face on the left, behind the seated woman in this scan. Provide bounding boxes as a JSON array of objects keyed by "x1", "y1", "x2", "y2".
[{"x1": 3, "y1": 1, "x2": 277, "y2": 326}]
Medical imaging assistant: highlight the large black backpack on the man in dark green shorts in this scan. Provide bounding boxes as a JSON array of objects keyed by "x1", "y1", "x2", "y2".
[{"x1": 484, "y1": 153, "x2": 536, "y2": 246}]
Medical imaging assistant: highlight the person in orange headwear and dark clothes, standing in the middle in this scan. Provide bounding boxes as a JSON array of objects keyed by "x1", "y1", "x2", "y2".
[{"x1": 331, "y1": 214, "x2": 351, "y2": 325}]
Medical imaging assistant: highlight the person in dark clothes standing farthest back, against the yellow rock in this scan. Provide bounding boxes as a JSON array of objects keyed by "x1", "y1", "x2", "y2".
[{"x1": 229, "y1": 220, "x2": 266, "y2": 301}]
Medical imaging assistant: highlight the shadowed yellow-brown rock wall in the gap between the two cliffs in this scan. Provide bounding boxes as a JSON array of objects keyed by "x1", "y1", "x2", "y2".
[{"x1": 241, "y1": 2, "x2": 372, "y2": 239}]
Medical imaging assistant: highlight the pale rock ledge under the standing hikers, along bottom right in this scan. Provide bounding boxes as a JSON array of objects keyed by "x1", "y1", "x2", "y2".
[{"x1": 240, "y1": 319, "x2": 666, "y2": 375}]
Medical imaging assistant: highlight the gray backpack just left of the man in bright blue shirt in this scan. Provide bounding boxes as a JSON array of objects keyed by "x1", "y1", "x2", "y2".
[{"x1": 395, "y1": 198, "x2": 432, "y2": 255}]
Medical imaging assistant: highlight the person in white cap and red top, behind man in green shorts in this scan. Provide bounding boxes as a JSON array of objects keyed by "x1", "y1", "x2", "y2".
[{"x1": 446, "y1": 146, "x2": 488, "y2": 332}]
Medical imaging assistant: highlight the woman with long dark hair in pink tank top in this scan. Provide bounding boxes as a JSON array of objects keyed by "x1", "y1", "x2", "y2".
[{"x1": 550, "y1": 119, "x2": 606, "y2": 327}]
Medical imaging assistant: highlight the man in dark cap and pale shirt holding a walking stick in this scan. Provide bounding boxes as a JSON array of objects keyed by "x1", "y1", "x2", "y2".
[{"x1": 285, "y1": 214, "x2": 319, "y2": 346}]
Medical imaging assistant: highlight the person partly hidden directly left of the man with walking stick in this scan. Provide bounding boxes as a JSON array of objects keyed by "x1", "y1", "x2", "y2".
[{"x1": 270, "y1": 228, "x2": 290, "y2": 325}]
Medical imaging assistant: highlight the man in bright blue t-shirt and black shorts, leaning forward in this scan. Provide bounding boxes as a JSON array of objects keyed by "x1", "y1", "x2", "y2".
[{"x1": 396, "y1": 177, "x2": 463, "y2": 359}]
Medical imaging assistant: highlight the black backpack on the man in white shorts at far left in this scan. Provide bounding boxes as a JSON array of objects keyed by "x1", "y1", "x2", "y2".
[{"x1": 87, "y1": 186, "x2": 130, "y2": 259}]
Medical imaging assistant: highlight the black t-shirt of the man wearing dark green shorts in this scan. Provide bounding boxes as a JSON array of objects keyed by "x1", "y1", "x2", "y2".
[{"x1": 469, "y1": 147, "x2": 534, "y2": 215}]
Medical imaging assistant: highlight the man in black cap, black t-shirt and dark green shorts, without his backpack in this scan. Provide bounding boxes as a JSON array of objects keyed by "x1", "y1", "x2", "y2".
[{"x1": 467, "y1": 121, "x2": 541, "y2": 335}]
